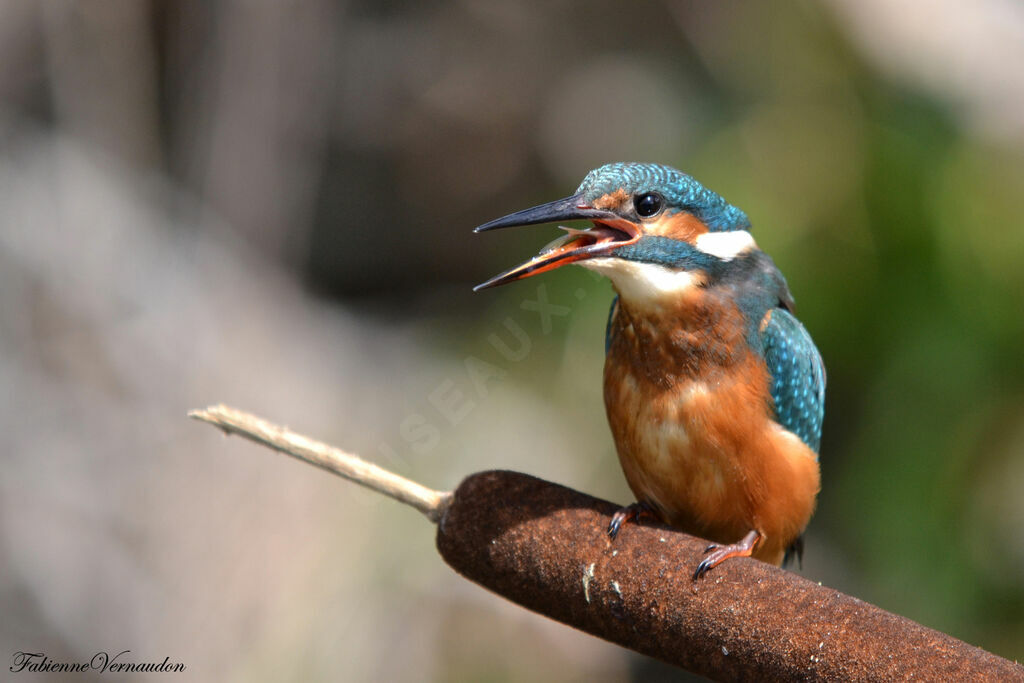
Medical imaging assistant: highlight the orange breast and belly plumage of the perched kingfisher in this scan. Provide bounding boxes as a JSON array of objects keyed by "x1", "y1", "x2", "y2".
[{"x1": 604, "y1": 302, "x2": 819, "y2": 564}]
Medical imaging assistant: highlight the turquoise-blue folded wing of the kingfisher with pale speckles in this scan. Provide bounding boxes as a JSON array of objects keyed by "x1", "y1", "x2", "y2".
[{"x1": 761, "y1": 308, "x2": 825, "y2": 453}]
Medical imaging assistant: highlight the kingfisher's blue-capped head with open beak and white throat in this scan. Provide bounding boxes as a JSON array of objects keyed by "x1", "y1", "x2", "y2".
[{"x1": 475, "y1": 163, "x2": 756, "y2": 299}]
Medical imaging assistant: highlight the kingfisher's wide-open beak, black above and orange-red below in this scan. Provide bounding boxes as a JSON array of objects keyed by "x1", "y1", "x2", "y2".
[{"x1": 473, "y1": 196, "x2": 640, "y2": 292}]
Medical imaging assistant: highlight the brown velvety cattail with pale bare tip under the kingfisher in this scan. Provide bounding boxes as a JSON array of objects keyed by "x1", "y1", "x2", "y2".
[{"x1": 189, "y1": 405, "x2": 1024, "y2": 681}]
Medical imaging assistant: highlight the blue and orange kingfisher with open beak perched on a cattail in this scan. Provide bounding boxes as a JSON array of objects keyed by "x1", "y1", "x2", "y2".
[{"x1": 474, "y1": 162, "x2": 825, "y2": 582}]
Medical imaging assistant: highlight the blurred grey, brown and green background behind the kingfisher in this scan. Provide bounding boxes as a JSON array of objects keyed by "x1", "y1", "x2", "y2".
[{"x1": 0, "y1": 0, "x2": 1024, "y2": 681}]
